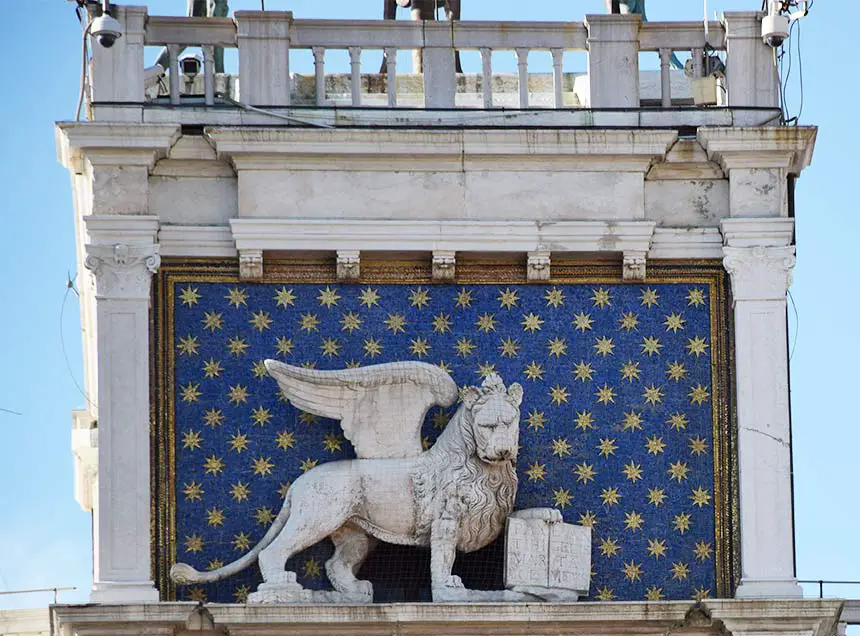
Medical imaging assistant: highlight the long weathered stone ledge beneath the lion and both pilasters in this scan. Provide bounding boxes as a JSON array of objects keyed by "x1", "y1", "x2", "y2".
[{"x1": 52, "y1": 599, "x2": 842, "y2": 636}]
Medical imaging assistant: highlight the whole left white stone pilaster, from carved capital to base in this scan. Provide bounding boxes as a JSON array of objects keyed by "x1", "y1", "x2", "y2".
[{"x1": 85, "y1": 243, "x2": 161, "y2": 603}]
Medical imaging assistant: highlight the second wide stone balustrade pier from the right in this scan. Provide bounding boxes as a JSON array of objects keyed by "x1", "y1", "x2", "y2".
[{"x1": 585, "y1": 15, "x2": 642, "y2": 108}]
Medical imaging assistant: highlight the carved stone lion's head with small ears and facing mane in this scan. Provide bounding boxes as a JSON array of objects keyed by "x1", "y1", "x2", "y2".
[{"x1": 463, "y1": 374, "x2": 523, "y2": 464}]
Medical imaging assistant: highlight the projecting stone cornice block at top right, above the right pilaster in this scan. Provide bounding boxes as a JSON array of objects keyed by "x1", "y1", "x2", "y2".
[{"x1": 698, "y1": 126, "x2": 818, "y2": 175}]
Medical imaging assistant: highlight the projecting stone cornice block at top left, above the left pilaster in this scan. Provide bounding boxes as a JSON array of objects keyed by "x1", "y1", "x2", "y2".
[{"x1": 56, "y1": 122, "x2": 180, "y2": 173}]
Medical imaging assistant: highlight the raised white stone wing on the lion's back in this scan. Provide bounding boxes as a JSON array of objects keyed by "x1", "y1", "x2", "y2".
[{"x1": 266, "y1": 360, "x2": 458, "y2": 459}]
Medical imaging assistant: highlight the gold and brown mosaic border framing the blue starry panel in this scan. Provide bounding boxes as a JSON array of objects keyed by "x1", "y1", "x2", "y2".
[{"x1": 150, "y1": 258, "x2": 740, "y2": 601}]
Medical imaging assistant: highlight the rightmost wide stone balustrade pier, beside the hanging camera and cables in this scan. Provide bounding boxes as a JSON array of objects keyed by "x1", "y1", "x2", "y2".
[{"x1": 724, "y1": 11, "x2": 779, "y2": 108}]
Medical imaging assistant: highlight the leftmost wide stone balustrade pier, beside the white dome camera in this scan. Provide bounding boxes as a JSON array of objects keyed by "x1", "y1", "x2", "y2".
[{"x1": 90, "y1": 5, "x2": 146, "y2": 104}]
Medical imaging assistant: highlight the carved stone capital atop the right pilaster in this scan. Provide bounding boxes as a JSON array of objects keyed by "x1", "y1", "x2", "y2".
[{"x1": 723, "y1": 246, "x2": 796, "y2": 302}]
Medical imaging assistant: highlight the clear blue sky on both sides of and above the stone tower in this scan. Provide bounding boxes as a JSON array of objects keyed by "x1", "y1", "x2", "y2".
[{"x1": 0, "y1": 0, "x2": 860, "y2": 608}]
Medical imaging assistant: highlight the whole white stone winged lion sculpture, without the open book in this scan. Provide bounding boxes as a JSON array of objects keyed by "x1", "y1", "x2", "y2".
[{"x1": 171, "y1": 360, "x2": 561, "y2": 602}]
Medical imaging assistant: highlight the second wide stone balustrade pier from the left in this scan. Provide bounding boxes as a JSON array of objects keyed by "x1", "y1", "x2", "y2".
[{"x1": 235, "y1": 11, "x2": 293, "y2": 106}]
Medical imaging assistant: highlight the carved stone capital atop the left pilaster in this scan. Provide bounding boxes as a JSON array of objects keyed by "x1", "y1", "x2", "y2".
[{"x1": 84, "y1": 243, "x2": 161, "y2": 300}]
